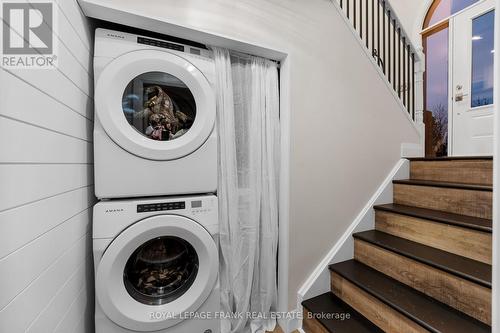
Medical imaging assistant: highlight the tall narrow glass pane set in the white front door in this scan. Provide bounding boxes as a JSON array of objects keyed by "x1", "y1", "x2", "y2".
[{"x1": 471, "y1": 11, "x2": 495, "y2": 107}]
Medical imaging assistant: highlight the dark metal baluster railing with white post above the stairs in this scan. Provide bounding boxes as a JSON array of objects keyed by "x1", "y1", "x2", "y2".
[{"x1": 332, "y1": 0, "x2": 423, "y2": 122}]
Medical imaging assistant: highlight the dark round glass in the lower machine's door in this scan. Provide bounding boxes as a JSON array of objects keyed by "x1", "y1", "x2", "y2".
[{"x1": 123, "y1": 236, "x2": 199, "y2": 305}]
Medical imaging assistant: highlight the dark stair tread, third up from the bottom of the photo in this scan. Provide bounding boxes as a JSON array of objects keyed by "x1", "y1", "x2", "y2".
[{"x1": 353, "y1": 230, "x2": 491, "y2": 288}]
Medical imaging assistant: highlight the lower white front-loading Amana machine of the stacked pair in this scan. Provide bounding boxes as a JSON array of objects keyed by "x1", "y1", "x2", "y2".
[{"x1": 93, "y1": 196, "x2": 220, "y2": 333}]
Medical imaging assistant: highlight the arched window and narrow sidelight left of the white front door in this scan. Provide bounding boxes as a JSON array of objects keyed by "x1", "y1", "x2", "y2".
[{"x1": 422, "y1": 0, "x2": 479, "y2": 156}]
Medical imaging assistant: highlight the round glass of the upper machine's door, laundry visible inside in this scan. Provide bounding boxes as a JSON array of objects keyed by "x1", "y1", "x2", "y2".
[{"x1": 122, "y1": 72, "x2": 196, "y2": 141}]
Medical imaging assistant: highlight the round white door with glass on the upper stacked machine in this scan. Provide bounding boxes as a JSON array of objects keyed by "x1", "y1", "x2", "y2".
[{"x1": 95, "y1": 50, "x2": 216, "y2": 160}]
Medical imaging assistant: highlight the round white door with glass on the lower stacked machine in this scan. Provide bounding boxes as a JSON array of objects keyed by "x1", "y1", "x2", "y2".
[{"x1": 95, "y1": 215, "x2": 219, "y2": 332}]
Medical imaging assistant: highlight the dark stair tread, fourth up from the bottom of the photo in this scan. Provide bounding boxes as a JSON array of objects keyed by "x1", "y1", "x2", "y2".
[{"x1": 374, "y1": 204, "x2": 493, "y2": 233}]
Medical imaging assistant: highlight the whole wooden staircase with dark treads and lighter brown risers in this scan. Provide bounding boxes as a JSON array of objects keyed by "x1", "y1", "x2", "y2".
[{"x1": 302, "y1": 157, "x2": 493, "y2": 333}]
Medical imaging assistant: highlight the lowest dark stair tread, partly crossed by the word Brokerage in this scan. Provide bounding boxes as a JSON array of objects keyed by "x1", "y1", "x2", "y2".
[{"x1": 302, "y1": 292, "x2": 383, "y2": 333}]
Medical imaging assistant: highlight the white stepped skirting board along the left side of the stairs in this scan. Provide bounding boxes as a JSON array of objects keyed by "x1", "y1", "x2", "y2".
[{"x1": 295, "y1": 159, "x2": 410, "y2": 329}]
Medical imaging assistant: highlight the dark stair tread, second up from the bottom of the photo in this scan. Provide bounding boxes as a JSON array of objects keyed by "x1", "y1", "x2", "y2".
[{"x1": 330, "y1": 260, "x2": 491, "y2": 333}]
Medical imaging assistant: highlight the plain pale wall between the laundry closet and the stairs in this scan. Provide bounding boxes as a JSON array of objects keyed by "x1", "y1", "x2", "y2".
[{"x1": 79, "y1": 0, "x2": 418, "y2": 309}]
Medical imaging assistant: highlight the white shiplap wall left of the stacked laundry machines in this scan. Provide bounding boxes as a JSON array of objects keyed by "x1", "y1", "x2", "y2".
[{"x1": 0, "y1": 0, "x2": 95, "y2": 333}]
